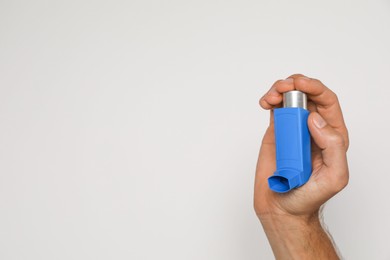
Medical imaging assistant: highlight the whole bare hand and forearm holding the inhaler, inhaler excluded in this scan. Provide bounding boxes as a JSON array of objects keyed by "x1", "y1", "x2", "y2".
[{"x1": 254, "y1": 74, "x2": 349, "y2": 260}]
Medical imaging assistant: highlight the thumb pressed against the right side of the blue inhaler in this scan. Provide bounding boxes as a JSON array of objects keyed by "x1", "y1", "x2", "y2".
[{"x1": 308, "y1": 112, "x2": 348, "y2": 190}]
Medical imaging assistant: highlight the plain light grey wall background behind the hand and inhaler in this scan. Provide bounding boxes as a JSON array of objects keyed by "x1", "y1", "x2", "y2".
[{"x1": 0, "y1": 0, "x2": 390, "y2": 260}]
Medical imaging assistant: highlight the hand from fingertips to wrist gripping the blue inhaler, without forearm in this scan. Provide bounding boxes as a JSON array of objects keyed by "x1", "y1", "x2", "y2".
[{"x1": 254, "y1": 75, "x2": 349, "y2": 217}]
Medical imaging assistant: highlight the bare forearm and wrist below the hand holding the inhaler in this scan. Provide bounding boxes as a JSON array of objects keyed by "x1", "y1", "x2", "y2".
[{"x1": 260, "y1": 212, "x2": 339, "y2": 260}]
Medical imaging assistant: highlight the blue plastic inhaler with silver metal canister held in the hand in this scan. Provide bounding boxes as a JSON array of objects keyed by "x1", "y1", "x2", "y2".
[{"x1": 268, "y1": 90, "x2": 312, "y2": 193}]
